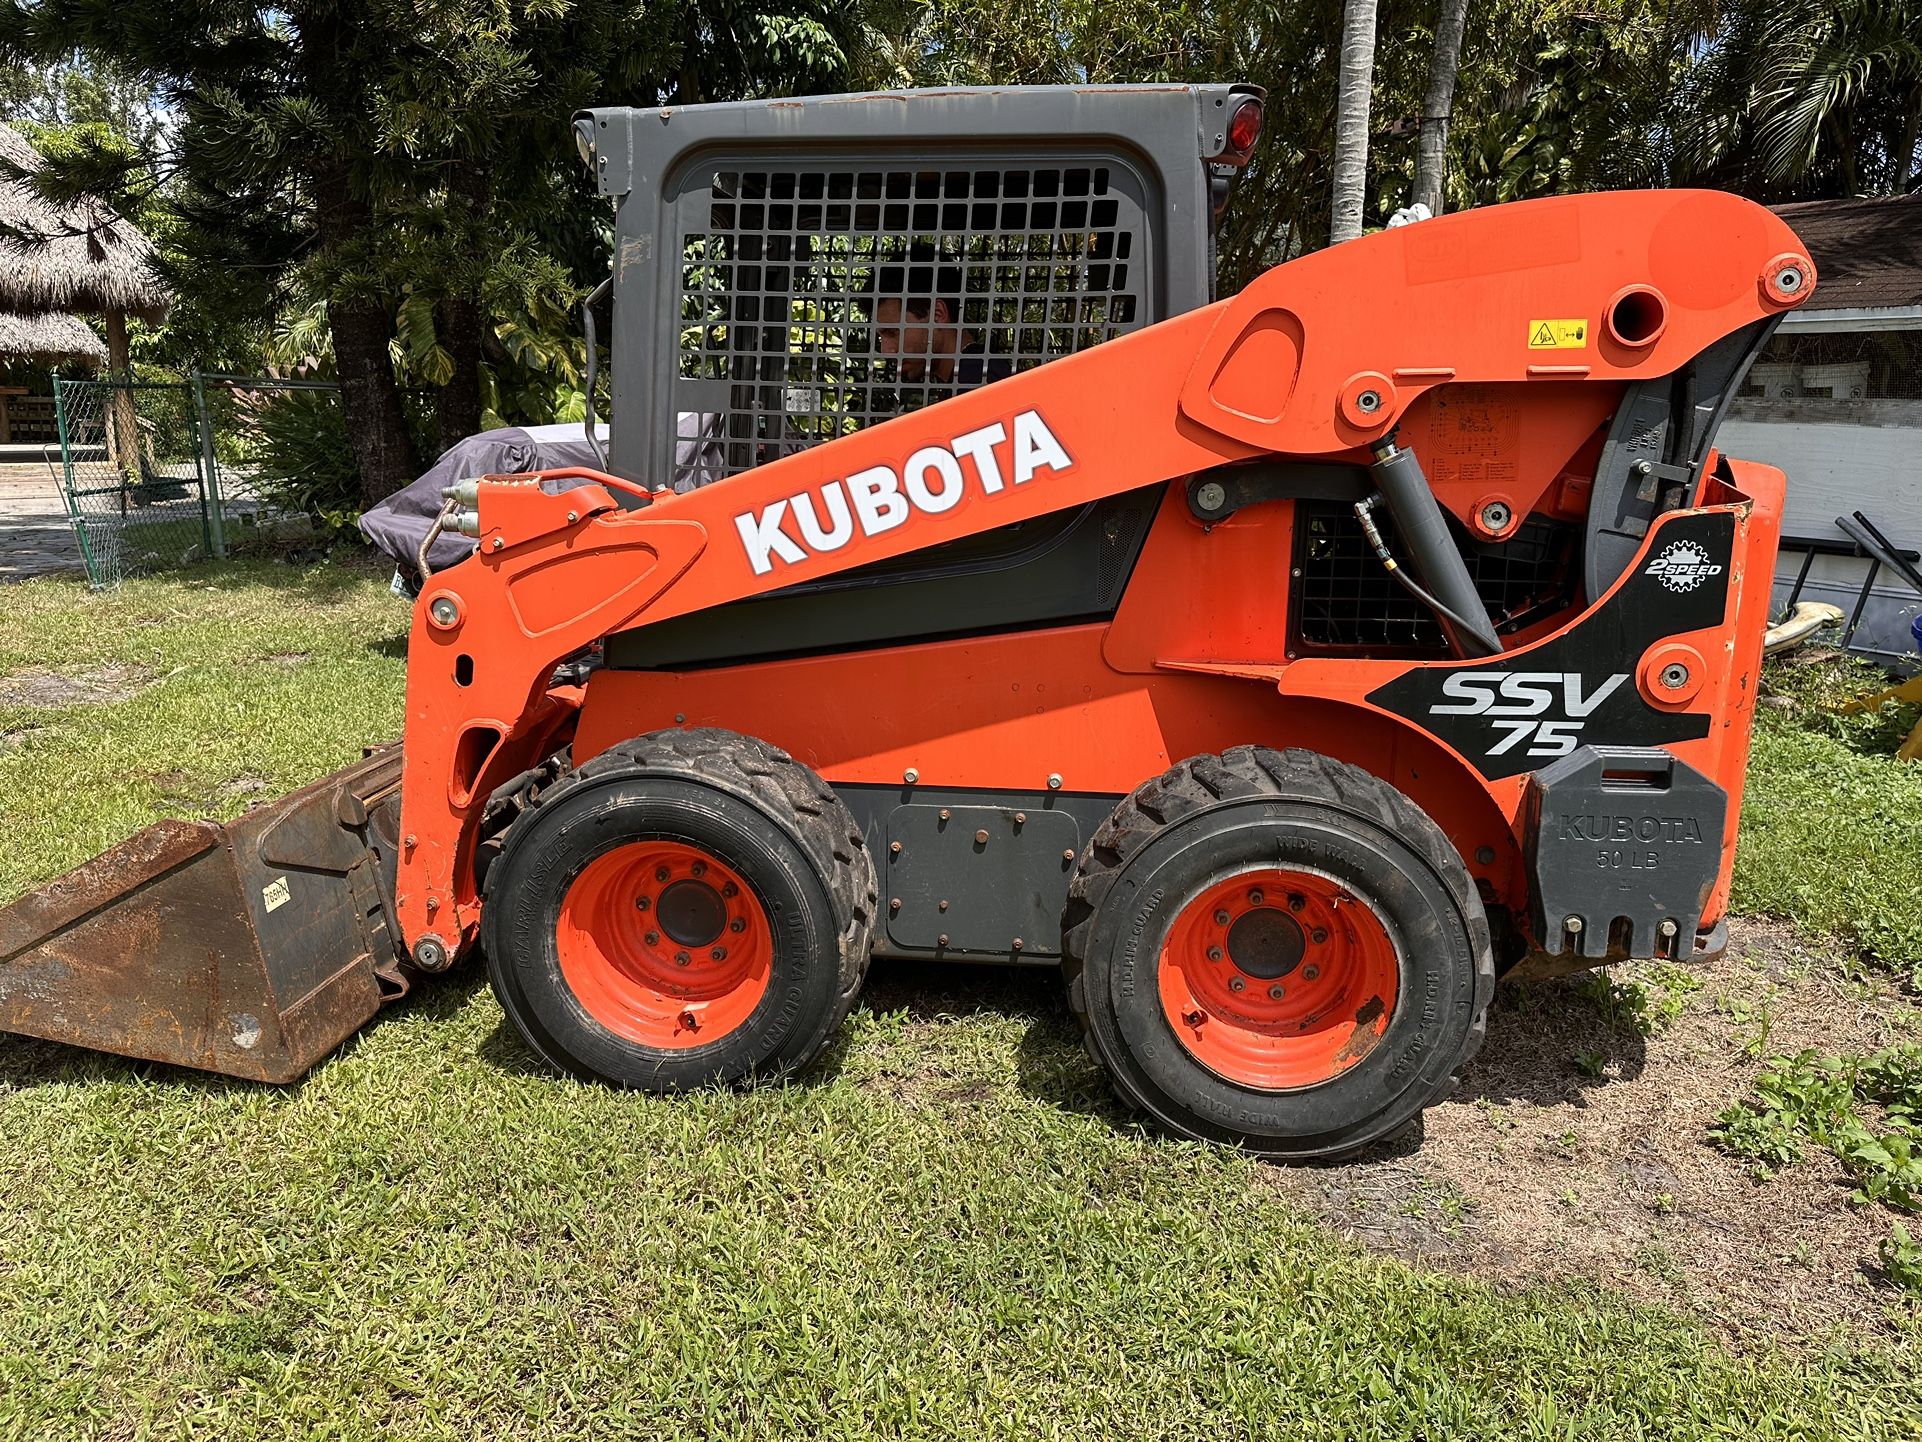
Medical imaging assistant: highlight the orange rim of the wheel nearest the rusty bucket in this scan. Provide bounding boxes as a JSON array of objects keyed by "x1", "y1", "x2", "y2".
[{"x1": 555, "y1": 840, "x2": 775, "y2": 1052}]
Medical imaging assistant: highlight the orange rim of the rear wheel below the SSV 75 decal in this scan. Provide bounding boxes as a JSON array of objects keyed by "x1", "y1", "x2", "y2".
[{"x1": 1159, "y1": 867, "x2": 1401, "y2": 1092}]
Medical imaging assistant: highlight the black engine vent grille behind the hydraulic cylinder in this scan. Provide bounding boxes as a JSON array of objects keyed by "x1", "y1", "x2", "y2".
[{"x1": 1292, "y1": 502, "x2": 1580, "y2": 656}]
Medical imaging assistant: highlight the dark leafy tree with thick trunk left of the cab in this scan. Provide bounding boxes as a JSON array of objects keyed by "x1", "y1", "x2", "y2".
[{"x1": 0, "y1": 0, "x2": 868, "y2": 502}]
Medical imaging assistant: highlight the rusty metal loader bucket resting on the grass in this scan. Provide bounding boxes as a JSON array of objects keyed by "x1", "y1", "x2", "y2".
[{"x1": 0, "y1": 746, "x2": 404, "y2": 1082}]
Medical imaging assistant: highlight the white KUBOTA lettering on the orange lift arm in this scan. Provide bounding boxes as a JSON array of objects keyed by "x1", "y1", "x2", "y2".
[{"x1": 734, "y1": 411, "x2": 1074, "y2": 575}]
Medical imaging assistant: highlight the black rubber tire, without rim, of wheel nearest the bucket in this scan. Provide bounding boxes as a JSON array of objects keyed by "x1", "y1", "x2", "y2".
[{"x1": 481, "y1": 727, "x2": 876, "y2": 1092}]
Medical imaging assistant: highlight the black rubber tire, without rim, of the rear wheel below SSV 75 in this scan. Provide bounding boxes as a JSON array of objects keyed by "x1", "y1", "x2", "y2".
[{"x1": 1063, "y1": 746, "x2": 1495, "y2": 1161}]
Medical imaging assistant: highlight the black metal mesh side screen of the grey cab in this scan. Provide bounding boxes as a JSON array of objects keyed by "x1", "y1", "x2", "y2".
[{"x1": 673, "y1": 162, "x2": 1153, "y2": 488}]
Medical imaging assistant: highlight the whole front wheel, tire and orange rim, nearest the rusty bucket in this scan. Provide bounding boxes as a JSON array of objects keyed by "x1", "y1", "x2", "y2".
[{"x1": 481, "y1": 729, "x2": 875, "y2": 1092}]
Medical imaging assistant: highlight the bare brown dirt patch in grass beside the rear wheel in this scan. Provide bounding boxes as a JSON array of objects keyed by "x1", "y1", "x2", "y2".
[{"x1": 1267, "y1": 921, "x2": 1922, "y2": 1344}]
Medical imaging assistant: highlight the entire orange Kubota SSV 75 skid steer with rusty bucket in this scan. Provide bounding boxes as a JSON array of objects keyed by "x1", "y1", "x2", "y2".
[{"x1": 0, "y1": 87, "x2": 1814, "y2": 1157}]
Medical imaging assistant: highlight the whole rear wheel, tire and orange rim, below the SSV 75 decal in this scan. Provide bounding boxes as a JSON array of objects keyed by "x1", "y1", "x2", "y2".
[{"x1": 1063, "y1": 746, "x2": 1495, "y2": 1159}]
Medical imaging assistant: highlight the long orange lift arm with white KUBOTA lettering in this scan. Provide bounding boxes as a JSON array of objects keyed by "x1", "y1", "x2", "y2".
[{"x1": 396, "y1": 190, "x2": 1814, "y2": 969}]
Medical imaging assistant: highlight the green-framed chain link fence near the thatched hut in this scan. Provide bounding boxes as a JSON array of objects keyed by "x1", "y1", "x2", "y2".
[{"x1": 54, "y1": 375, "x2": 340, "y2": 588}]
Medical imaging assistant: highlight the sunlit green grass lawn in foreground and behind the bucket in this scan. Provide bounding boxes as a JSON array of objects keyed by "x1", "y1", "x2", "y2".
[{"x1": 0, "y1": 567, "x2": 1922, "y2": 1442}]
